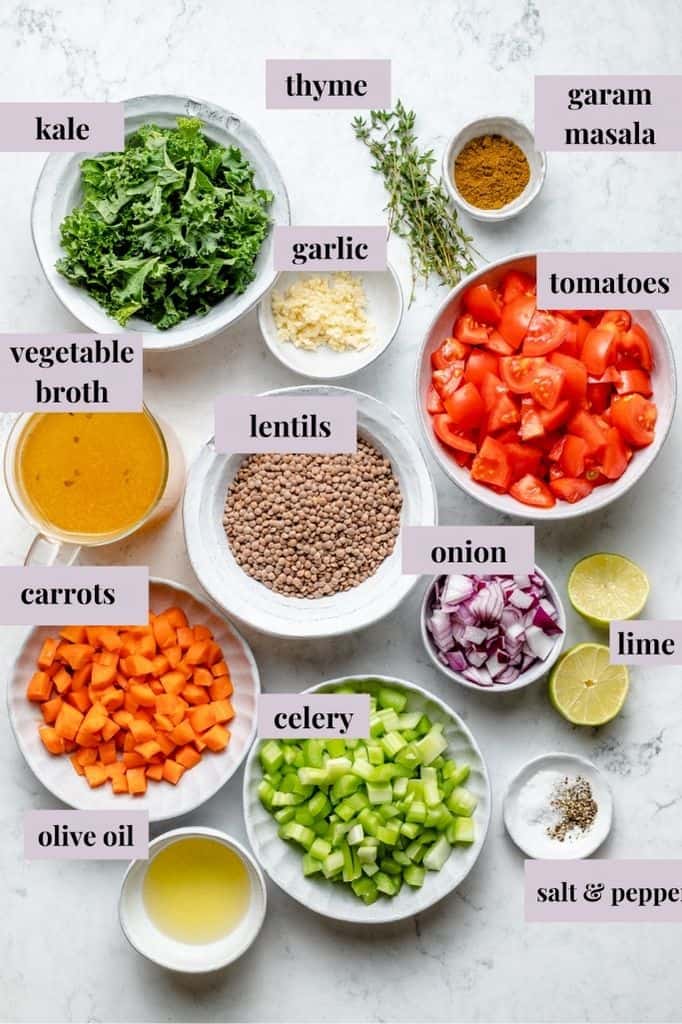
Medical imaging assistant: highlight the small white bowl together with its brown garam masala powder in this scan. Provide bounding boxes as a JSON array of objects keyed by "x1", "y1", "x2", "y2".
[{"x1": 442, "y1": 116, "x2": 547, "y2": 221}]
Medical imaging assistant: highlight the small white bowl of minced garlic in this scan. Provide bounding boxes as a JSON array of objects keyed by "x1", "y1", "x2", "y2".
[{"x1": 258, "y1": 264, "x2": 402, "y2": 381}]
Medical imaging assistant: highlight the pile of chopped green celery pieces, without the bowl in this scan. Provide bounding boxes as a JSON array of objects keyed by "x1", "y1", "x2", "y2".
[{"x1": 258, "y1": 681, "x2": 476, "y2": 904}]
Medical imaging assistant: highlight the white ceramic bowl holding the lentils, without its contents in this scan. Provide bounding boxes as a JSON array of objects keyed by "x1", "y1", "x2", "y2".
[{"x1": 183, "y1": 384, "x2": 437, "y2": 638}]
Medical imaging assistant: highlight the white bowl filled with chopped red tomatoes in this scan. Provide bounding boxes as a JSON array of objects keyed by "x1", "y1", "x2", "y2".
[{"x1": 417, "y1": 254, "x2": 677, "y2": 519}]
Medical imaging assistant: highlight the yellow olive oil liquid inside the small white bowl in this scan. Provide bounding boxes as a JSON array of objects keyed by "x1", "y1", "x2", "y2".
[{"x1": 142, "y1": 837, "x2": 251, "y2": 944}]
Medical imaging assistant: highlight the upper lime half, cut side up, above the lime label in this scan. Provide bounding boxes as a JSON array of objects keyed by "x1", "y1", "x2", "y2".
[{"x1": 568, "y1": 554, "x2": 649, "y2": 628}]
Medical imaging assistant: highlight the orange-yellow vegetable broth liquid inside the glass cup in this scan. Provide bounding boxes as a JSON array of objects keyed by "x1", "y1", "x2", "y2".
[{"x1": 14, "y1": 413, "x2": 168, "y2": 539}]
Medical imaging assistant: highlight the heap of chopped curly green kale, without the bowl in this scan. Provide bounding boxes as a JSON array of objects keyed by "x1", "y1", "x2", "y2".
[{"x1": 56, "y1": 118, "x2": 272, "y2": 331}]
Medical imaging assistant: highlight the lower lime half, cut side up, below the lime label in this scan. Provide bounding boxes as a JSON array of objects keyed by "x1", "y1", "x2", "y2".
[{"x1": 549, "y1": 643, "x2": 630, "y2": 725}]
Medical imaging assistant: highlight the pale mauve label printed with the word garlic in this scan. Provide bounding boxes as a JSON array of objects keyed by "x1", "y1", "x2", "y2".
[{"x1": 272, "y1": 224, "x2": 388, "y2": 270}]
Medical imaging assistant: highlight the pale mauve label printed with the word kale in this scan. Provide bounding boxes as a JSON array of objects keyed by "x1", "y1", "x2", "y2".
[{"x1": 0, "y1": 102, "x2": 124, "y2": 153}]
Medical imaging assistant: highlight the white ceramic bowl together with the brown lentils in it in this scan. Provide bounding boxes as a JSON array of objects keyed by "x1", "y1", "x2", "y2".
[{"x1": 183, "y1": 385, "x2": 437, "y2": 638}]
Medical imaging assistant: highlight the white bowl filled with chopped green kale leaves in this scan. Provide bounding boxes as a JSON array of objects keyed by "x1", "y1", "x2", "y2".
[{"x1": 32, "y1": 96, "x2": 291, "y2": 350}]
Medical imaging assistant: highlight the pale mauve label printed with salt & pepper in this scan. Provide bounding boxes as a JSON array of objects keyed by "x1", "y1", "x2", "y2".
[{"x1": 524, "y1": 860, "x2": 682, "y2": 924}]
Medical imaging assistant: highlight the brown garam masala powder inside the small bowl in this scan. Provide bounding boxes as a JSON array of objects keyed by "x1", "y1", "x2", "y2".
[{"x1": 455, "y1": 135, "x2": 530, "y2": 210}]
